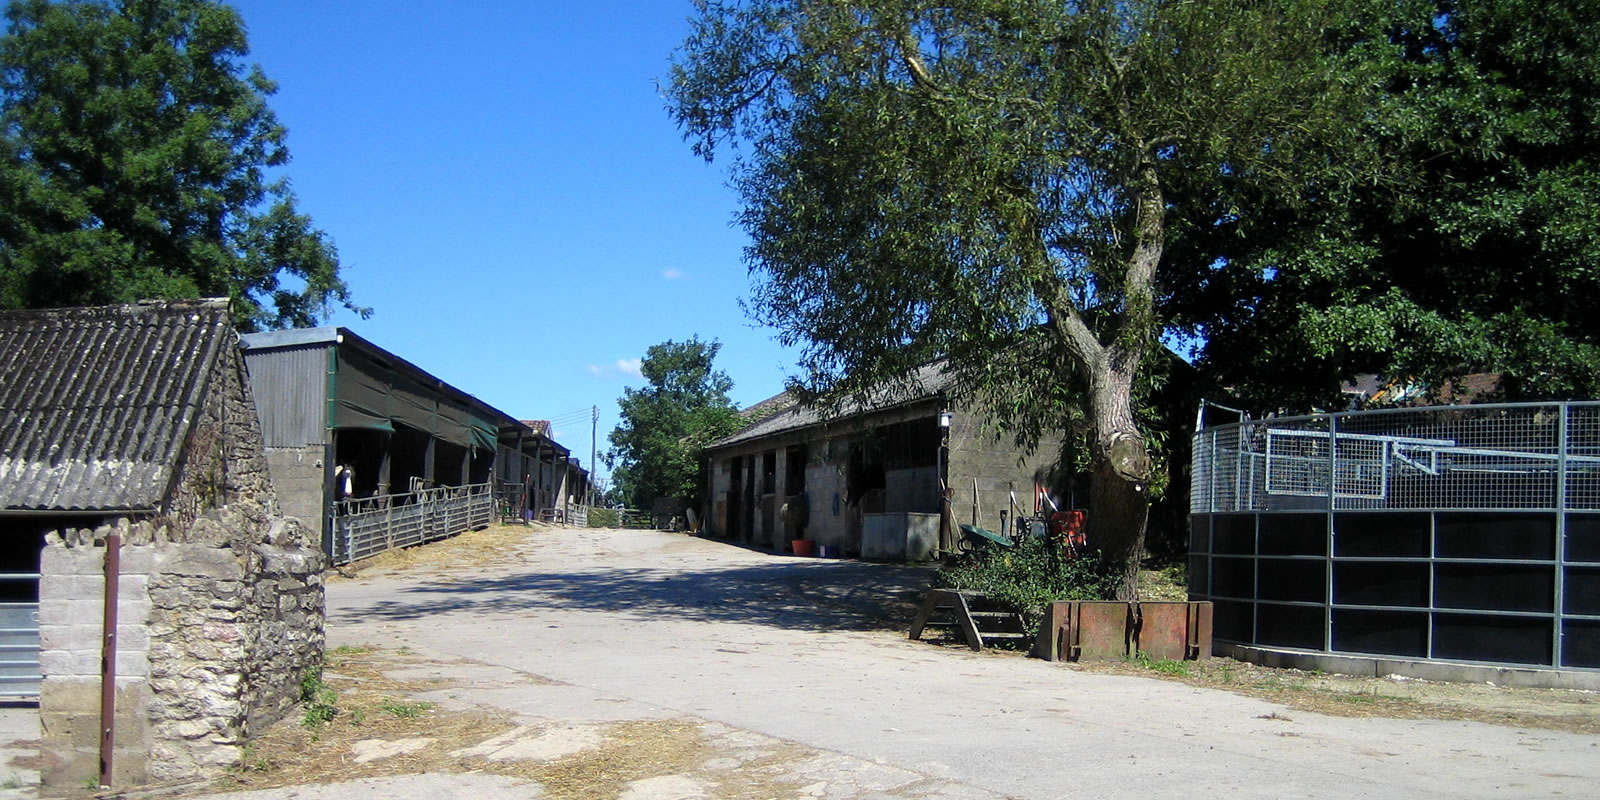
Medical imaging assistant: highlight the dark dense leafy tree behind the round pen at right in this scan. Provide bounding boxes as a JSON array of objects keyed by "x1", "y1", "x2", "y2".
[{"x1": 1171, "y1": 0, "x2": 1600, "y2": 408}]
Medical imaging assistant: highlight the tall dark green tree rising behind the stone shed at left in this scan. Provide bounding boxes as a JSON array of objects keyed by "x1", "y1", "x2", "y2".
[{"x1": 0, "y1": 0, "x2": 365, "y2": 330}]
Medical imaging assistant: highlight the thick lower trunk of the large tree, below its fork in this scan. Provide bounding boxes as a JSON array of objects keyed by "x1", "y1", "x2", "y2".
[{"x1": 1086, "y1": 365, "x2": 1150, "y2": 600}]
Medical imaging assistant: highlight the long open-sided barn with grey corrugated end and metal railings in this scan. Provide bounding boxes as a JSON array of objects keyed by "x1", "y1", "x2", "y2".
[{"x1": 242, "y1": 326, "x2": 587, "y2": 563}]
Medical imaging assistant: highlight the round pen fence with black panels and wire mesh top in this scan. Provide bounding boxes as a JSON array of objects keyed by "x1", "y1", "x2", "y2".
[{"x1": 1189, "y1": 403, "x2": 1600, "y2": 669}]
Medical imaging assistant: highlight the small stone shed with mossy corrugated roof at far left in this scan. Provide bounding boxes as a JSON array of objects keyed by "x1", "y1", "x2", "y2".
[{"x1": 0, "y1": 299, "x2": 325, "y2": 786}]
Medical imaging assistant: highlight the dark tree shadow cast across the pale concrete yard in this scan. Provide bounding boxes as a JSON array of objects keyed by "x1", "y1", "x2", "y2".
[{"x1": 330, "y1": 558, "x2": 931, "y2": 630}]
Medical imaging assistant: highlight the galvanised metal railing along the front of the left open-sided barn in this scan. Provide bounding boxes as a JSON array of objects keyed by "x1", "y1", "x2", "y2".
[{"x1": 333, "y1": 483, "x2": 494, "y2": 563}]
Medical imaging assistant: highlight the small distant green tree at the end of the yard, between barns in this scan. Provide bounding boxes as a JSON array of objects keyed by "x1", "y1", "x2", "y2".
[{"x1": 606, "y1": 336, "x2": 739, "y2": 509}]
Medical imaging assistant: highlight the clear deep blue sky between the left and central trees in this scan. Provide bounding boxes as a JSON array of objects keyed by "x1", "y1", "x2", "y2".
[{"x1": 232, "y1": 0, "x2": 795, "y2": 472}]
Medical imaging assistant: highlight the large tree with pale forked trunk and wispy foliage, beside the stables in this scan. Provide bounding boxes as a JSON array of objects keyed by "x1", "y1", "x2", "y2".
[{"x1": 669, "y1": 0, "x2": 1366, "y2": 597}]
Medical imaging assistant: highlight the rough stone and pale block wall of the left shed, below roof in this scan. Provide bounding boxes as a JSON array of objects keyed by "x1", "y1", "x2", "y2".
[{"x1": 40, "y1": 350, "x2": 325, "y2": 787}]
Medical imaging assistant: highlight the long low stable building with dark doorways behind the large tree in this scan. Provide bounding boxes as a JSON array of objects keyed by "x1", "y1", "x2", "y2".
[{"x1": 706, "y1": 366, "x2": 1075, "y2": 562}]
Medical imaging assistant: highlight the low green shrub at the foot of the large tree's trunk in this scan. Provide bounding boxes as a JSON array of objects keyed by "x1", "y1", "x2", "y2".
[{"x1": 933, "y1": 536, "x2": 1122, "y2": 634}]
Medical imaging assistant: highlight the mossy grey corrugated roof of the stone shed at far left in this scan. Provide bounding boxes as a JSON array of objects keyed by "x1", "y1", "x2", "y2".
[{"x1": 0, "y1": 299, "x2": 238, "y2": 510}]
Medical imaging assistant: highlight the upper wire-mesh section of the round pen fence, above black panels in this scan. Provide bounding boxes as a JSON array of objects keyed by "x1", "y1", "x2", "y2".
[{"x1": 1189, "y1": 402, "x2": 1600, "y2": 514}]
